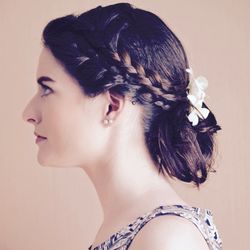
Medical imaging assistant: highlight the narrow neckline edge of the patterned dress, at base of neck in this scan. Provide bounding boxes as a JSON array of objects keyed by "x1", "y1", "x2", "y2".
[{"x1": 88, "y1": 204, "x2": 211, "y2": 250}]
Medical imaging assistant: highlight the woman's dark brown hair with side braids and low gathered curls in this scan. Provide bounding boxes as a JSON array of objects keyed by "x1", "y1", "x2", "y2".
[{"x1": 42, "y1": 3, "x2": 221, "y2": 188}]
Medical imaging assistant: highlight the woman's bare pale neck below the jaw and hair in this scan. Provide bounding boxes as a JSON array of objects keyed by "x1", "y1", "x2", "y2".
[{"x1": 82, "y1": 141, "x2": 184, "y2": 222}]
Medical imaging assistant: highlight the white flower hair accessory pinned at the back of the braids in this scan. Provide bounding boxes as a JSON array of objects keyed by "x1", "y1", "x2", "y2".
[{"x1": 186, "y1": 68, "x2": 210, "y2": 126}]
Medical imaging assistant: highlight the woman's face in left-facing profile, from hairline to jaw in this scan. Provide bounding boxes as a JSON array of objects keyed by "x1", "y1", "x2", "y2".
[{"x1": 23, "y1": 48, "x2": 106, "y2": 167}]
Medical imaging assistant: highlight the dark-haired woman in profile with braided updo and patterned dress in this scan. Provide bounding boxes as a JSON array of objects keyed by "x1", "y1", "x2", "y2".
[{"x1": 23, "y1": 3, "x2": 221, "y2": 250}]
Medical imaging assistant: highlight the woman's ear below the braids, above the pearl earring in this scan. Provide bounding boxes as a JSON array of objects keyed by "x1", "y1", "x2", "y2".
[{"x1": 104, "y1": 91, "x2": 125, "y2": 120}]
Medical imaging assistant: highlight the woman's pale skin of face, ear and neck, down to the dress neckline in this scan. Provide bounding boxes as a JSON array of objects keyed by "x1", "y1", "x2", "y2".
[{"x1": 22, "y1": 48, "x2": 203, "y2": 246}]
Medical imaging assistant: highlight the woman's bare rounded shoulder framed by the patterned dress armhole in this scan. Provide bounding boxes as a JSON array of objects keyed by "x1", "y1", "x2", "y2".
[{"x1": 129, "y1": 215, "x2": 209, "y2": 250}]
